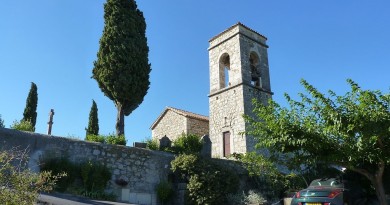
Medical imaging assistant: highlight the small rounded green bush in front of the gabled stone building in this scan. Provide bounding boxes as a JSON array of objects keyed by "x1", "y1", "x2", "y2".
[{"x1": 172, "y1": 133, "x2": 203, "y2": 154}]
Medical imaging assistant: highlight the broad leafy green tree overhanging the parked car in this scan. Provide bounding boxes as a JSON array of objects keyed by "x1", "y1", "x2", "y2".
[{"x1": 245, "y1": 79, "x2": 390, "y2": 205}]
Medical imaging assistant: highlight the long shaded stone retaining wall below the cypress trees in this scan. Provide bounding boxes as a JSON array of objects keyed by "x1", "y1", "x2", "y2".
[{"x1": 0, "y1": 128, "x2": 174, "y2": 204}]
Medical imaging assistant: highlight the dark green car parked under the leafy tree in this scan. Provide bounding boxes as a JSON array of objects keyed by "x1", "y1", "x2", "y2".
[{"x1": 291, "y1": 178, "x2": 349, "y2": 205}]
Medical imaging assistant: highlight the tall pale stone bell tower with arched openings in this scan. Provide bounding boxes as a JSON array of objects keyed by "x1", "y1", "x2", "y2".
[{"x1": 208, "y1": 22, "x2": 273, "y2": 157}]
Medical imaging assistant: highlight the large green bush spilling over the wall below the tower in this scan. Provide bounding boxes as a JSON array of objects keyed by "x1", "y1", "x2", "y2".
[{"x1": 171, "y1": 154, "x2": 238, "y2": 204}]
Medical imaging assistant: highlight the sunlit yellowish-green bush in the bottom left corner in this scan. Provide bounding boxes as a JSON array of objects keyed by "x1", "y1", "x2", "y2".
[{"x1": 0, "y1": 149, "x2": 64, "y2": 205}]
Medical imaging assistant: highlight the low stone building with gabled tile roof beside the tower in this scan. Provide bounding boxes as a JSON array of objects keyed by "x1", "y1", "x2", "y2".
[{"x1": 150, "y1": 107, "x2": 209, "y2": 141}]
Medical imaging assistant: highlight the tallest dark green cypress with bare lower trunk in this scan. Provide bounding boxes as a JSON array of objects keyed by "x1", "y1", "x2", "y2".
[{"x1": 92, "y1": 0, "x2": 151, "y2": 136}]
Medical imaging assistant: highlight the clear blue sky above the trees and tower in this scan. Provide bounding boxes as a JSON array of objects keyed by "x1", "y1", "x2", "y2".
[{"x1": 0, "y1": 0, "x2": 390, "y2": 145}]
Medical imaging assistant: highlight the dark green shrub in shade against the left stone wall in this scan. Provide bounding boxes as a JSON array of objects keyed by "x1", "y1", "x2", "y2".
[{"x1": 41, "y1": 158, "x2": 112, "y2": 199}]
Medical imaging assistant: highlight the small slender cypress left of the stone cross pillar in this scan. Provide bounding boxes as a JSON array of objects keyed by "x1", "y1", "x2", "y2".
[{"x1": 22, "y1": 82, "x2": 38, "y2": 132}]
